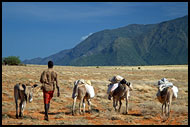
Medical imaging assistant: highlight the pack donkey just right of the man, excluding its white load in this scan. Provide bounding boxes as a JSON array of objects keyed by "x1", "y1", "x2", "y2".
[{"x1": 72, "y1": 80, "x2": 91, "y2": 115}]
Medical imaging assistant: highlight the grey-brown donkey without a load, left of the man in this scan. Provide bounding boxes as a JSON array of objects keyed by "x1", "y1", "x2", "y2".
[{"x1": 14, "y1": 83, "x2": 38, "y2": 119}]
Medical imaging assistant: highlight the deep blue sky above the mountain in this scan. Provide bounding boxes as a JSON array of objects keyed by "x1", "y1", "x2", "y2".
[{"x1": 2, "y1": 2, "x2": 188, "y2": 60}]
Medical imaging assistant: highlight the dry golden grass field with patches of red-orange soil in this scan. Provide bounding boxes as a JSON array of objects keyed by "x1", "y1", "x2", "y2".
[{"x1": 2, "y1": 65, "x2": 188, "y2": 125}]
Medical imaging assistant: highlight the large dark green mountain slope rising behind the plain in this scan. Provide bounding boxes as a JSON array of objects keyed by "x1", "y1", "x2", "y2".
[{"x1": 23, "y1": 16, "x2": 188, "y2": 66}]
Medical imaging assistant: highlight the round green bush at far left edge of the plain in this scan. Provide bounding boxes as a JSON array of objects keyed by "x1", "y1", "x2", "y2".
[{"x1": 2, "y1": 56, "x2": 21, "y2": 65}]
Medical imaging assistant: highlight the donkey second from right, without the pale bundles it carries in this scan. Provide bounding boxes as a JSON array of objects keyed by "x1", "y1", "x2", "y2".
[{"x1": 112, "y1": 79, "x2": 132, "y2": 114}]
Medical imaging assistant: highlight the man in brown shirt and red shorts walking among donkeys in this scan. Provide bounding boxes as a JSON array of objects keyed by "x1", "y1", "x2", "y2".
[{"x1": 40, "y1": 61, "x2": 60, "y2": 121}]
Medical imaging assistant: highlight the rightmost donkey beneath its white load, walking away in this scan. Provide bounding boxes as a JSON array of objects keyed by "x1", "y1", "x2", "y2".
[{"x1": 157, "y1": 87, "x2": 174, "y2": 118}]
